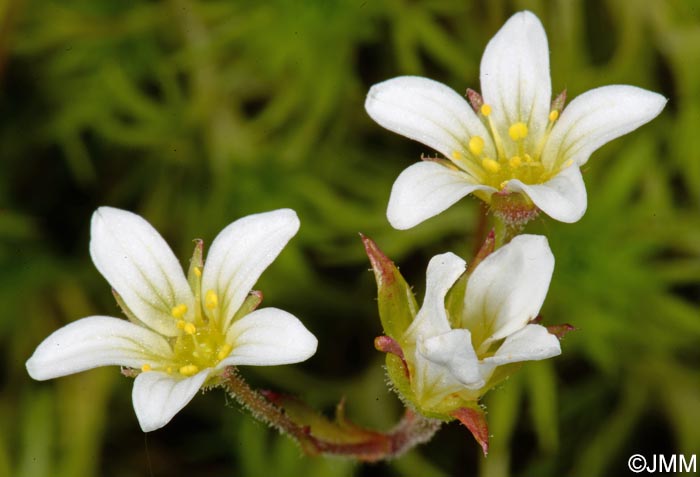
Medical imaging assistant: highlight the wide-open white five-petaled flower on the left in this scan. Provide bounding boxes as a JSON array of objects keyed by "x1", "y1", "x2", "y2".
[{"x1": 27, "y1": 207, "x2": 317, "y2": 432}]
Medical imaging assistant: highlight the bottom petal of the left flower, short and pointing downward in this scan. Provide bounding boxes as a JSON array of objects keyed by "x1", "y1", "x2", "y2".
[{"x1": 131, "y1": 369, "x2": 211, "y2": 432}]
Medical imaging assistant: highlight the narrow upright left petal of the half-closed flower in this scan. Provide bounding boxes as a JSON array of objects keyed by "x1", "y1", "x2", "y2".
[{"x1": 406, "y1": 252, "x2": 466, "y2": 342}]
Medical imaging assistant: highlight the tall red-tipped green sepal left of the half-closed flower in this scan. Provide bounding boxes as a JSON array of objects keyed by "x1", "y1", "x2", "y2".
[{"x1": 360, "y1": 234, "x2": 418, "y2": 342}]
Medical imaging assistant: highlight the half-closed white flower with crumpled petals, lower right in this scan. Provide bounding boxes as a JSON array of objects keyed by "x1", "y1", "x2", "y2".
[{"x1": 402, "y1": 235, "x2": 561, "y2": 408}]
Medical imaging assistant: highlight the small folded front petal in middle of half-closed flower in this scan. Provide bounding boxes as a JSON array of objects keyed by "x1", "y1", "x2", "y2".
[{"x1": 418, "y1": 329, "x2": 484, "y2": 389}]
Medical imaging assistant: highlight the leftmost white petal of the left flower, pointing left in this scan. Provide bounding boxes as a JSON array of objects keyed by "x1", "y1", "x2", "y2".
[{"x1": 26, "y1": 316, "x2": 171, "y2": 380}]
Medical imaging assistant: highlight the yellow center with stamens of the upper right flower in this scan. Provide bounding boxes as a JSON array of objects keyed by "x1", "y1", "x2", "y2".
[{"x1": 452, "y1": 104, "x2": 572, "y2": 190}]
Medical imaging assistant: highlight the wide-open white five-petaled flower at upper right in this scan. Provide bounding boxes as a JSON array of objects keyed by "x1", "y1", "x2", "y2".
[{"x1": 365, "y1": 12, "x2": 666, "y2": 229}]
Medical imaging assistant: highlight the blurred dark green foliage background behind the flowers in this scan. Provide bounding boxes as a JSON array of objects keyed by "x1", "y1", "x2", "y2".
[{"x1": 0, "y1": 0, "x2": 700, "y2": 477}]
